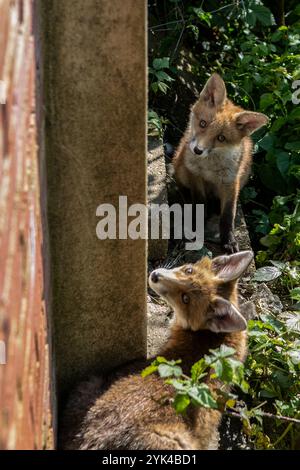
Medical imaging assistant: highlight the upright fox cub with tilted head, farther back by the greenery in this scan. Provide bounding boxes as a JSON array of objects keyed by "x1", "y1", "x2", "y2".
[{"x1": 173, "y1": 73, "x2": 268, "y2": 253}]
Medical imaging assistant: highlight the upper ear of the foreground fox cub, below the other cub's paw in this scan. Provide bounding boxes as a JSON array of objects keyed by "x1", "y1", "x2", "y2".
[{"x1": 212, "y1": 251, "x2": 253, "y2": 282}]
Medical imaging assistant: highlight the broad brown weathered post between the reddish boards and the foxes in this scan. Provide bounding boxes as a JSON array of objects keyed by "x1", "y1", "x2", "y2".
[{"x1": 36, "y1": 0, "x2": 146, "y2": 393}]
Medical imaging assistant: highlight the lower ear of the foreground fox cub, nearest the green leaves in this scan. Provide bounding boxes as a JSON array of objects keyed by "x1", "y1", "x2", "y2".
[{"x1": 206, "y1": 297, "x2": 247, "y2": 333}]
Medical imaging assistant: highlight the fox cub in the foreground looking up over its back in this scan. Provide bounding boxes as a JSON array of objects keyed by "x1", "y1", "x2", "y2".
[{"x1": 61, "y1": 251, "x2": 253, "y2": 450}]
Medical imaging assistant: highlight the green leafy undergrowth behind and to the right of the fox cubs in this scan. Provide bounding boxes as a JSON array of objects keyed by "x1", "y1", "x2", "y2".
[{"x1": 148, "y1": 0, "x2": 300, "y2": 448}]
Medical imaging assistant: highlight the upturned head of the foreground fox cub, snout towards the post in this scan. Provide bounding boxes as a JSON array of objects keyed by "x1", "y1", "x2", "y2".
[{"x1": 149, "y1": 251, "x2": 253, "y2": 333}]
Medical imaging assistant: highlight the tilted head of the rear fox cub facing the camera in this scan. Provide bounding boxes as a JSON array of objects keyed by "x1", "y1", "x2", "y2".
[{"x1": 189, "y1": 73, "x2": 268, "y2": 158}]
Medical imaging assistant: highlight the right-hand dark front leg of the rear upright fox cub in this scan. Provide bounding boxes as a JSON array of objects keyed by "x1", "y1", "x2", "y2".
[{"x1": 220, "y1": 188, "x2": 239, "y2": 253}]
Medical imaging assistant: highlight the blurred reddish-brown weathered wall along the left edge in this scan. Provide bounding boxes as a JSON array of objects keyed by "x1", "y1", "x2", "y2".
[{"x1": 0, "y1": 0, "x2": 53, "y2": 449}]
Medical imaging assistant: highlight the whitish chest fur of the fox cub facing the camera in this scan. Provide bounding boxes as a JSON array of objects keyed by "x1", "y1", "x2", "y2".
[{"x1": 184, "y1": 145, "x2": 242, "y2": 185}]
